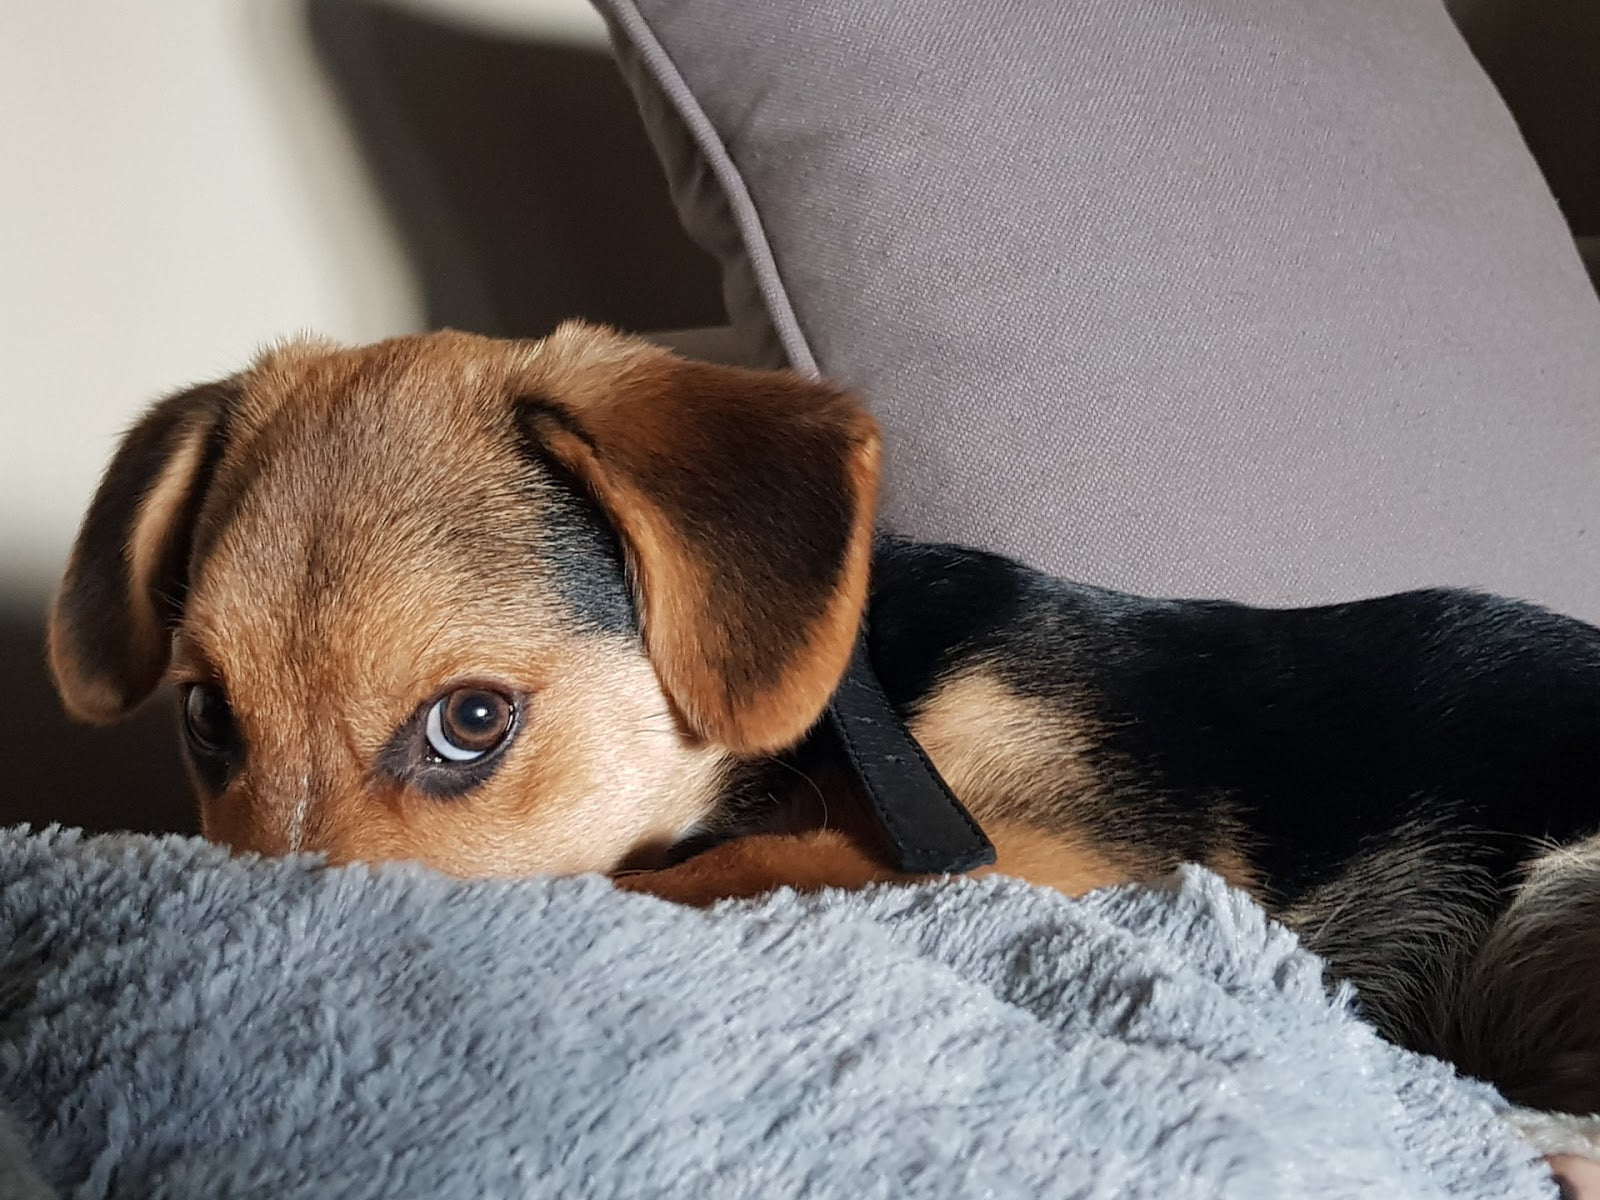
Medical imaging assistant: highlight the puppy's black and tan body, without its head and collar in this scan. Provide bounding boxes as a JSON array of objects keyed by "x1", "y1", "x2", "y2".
[{"x1": 640, "y1": 538, "x2": 1600, "y2": 1106}]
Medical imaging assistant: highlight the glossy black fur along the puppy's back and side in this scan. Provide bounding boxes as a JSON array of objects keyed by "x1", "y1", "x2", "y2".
[{"x1": 869, "y1": 538, "x2": 1600, "y2": 907}]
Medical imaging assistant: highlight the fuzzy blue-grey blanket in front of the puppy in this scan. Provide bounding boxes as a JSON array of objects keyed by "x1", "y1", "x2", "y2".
[{"x1": 0, "y1": 830, "x2": 1554, "y2": 1200}]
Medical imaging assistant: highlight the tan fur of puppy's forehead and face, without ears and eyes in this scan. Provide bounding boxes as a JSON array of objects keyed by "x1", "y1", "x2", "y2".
[{"x1": 174, "y1": 334, "x2": 725, "y2": 875}]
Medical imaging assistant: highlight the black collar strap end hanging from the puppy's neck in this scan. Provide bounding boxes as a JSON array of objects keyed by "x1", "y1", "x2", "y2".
[{"x1": 827, "y1": 632, "x2": 995, "y2": 875}]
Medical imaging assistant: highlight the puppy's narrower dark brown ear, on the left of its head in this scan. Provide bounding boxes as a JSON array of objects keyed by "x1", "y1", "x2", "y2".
[{"x1": 48, "y1": 382, "x2": 235, "y2": 722}]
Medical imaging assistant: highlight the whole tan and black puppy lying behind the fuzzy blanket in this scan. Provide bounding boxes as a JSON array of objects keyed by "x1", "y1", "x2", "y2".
[{"x1": 48, "y1": 323, "x2": 1600, "y2": 1112}]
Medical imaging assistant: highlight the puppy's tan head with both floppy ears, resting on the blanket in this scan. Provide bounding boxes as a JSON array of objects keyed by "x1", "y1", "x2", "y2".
[{"x1": 50, "y1": 323, "x2": 878, "y2": 874}]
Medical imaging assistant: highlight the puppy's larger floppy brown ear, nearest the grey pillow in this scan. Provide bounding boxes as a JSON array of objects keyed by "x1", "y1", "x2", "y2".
[{"x1": 518, "y1": 352, "x2": 878, "y2": 755}]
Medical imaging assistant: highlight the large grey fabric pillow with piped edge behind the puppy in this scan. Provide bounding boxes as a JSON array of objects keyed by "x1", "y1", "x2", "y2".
[{"x1": 597, "y1": 0, "x2": 1600, "y2": 619}]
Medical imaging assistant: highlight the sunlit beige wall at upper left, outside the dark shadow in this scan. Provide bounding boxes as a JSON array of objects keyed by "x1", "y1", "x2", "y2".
[{"x1": 0, "y1": 0, "x2": 605, "y2": 608}]
